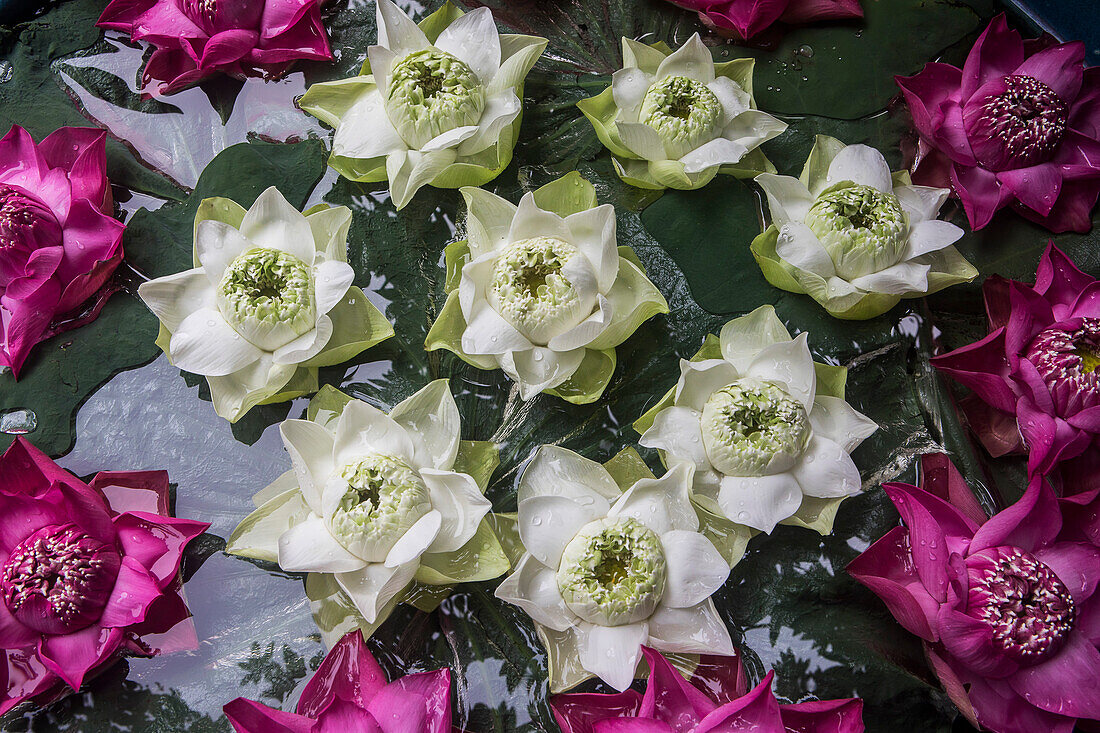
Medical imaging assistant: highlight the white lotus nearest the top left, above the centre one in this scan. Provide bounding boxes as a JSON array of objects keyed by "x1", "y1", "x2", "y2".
[{"x1": 298, "y1": 0, "x2": 547, "y2": 209}]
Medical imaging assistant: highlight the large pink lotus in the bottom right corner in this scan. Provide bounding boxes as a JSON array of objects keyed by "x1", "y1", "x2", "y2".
[{"x1": 848, "y1": 456, "x2": 1100, "y2": 733}]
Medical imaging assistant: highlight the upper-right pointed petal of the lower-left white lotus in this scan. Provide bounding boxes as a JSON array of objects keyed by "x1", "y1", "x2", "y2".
[{"x1": 389, "y1": 380, "x2": 462, "y2": 471}]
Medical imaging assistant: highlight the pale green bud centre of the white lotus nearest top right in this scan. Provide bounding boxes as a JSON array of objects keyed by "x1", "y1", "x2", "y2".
[{"x1": 639, "y1": 76, "x2": 722, "y2": 160}]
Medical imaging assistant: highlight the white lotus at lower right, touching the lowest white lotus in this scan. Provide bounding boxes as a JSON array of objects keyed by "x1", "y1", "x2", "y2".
[{"x1": 639, "y1": 306, "x2": 878, "y2": 532}]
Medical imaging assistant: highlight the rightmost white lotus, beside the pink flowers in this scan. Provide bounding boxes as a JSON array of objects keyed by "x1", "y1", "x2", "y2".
[{"x1": 752, "y1": 135, "x2": 978, "y2": 320}]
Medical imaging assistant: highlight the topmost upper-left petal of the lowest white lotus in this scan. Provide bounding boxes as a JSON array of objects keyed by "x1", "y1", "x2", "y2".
[{"x1": 517, "y1": 446, "x2": 622, "y2": 506}]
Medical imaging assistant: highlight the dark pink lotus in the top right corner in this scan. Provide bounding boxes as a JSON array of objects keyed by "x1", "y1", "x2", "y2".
[{"x1": 898, "y1": 14, "x2": 1100, "y2": 232}]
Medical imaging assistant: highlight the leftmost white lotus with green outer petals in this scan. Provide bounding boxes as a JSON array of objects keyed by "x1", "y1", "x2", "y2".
[{"x1": 138, "y1": 187, "x2": 394, "y2": 423}]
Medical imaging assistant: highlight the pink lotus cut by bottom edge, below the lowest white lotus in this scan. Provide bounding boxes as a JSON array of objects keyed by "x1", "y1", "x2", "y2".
[{"x1": 550, "y1": 646, "x2": 864, "y2": 733}]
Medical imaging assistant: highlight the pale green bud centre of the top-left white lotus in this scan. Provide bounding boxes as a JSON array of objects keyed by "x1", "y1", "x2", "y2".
[{"x1": 385, "y1": 48, "x2": 485, "y2": 150}]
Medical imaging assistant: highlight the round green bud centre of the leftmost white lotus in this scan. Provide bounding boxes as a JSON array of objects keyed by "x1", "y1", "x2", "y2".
[{"x1": 218, "y1": 248, "x2": 317, "y2": 351}]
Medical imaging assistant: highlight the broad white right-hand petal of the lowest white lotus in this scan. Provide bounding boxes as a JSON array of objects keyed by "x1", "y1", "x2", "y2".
[{"x1": 661, "y1": 529, "x2": 729, "y2": 609}]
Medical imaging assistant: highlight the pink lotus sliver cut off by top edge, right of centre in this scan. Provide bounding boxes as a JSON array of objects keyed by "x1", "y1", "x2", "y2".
[{"x1": 670, "y1": 0, "x2": 864, "y2": 41}]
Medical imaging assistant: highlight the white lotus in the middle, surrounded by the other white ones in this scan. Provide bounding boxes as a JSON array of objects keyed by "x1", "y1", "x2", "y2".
[{"x1": 427, "y1": 173, "x2": 669, "y2": 404}]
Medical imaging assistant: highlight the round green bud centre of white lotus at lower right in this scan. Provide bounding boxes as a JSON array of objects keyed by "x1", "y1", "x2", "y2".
[{"x1": 700, "y1": 379, "x2": 811, "y2": 477}]
